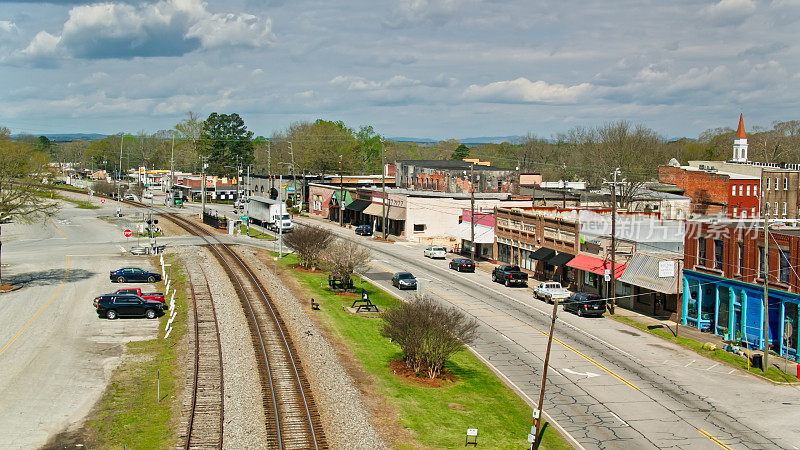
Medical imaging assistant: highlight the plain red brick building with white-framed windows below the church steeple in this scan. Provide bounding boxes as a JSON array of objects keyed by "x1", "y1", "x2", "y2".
[{"x1": 658, "y1": 166, "x2": 761, "y2": 218}]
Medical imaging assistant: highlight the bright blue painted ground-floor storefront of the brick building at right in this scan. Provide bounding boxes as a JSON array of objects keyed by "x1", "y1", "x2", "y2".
[{"x1": 681, "y1": 269, "x2": 800, "y2": 359}]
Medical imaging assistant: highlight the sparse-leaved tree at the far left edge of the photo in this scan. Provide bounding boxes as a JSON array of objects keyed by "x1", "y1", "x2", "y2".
[{"x1": 0, "y1": 137, "x2": 58, "y2": 281}]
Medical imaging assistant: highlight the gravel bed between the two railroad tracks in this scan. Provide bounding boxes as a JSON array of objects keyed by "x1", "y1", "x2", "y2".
[{"x1": 175, "y1": 247, "x2": 267, "y2": 449}]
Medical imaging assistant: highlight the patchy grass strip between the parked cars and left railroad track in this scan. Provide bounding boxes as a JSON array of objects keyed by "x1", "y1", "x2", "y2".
[{"x1": 86, "y1": 255, "x2": 187, "y2": 449}]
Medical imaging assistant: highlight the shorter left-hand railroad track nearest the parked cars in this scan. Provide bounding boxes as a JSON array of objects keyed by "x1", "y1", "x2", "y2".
[{"x1": 181, "y1": 265, "x2": 225, "y2": 449}]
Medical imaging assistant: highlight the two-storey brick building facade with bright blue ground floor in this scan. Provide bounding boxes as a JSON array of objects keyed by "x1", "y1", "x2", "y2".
[{"x1": 681, "y1": 221, "x2": 800, "y2": 358}]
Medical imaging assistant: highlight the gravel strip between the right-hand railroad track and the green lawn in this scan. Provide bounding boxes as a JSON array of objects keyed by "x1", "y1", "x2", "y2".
[{"x1": 234, "y1": 247, "x2": 388, "y2": 449}]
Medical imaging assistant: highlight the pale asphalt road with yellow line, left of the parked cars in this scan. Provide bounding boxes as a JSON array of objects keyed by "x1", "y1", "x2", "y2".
[{"x1": 0, "y1": 198, "x2": 158, "y2": 449}]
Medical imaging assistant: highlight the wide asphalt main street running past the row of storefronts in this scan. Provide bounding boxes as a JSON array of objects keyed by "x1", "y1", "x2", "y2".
[{"x1": 300, "y1": 219, "x2": 800, "y2": 449}]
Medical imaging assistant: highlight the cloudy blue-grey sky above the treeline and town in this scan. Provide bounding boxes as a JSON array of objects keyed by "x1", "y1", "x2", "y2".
[{"x1": 0, "y1": 0, "x2": 800, "y2": 138}]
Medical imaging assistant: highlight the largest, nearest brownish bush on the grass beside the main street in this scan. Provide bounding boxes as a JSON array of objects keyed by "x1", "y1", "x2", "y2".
[{"x1": 381, "y1": 295, "x2": 478, "y2": 379}]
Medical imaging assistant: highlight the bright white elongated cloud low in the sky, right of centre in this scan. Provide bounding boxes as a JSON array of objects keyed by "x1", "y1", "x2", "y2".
[{"x1": 463, "y1": 77, "x2": 592, "y2": 103}]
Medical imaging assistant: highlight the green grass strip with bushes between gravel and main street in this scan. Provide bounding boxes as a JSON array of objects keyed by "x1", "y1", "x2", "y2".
[{"x1": 272, "y1": 255, "x2": 571, "y2": 449}]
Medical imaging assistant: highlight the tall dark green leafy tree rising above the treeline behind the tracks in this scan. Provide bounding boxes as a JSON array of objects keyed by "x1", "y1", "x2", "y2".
[{"x1": 200, "y1": 112, "x2": 255, "y2": 178}]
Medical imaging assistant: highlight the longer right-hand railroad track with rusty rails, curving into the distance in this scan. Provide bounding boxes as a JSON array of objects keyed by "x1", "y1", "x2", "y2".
[{"x1": 161, "y1": 211, "x2": 328, "y2": 449}]
